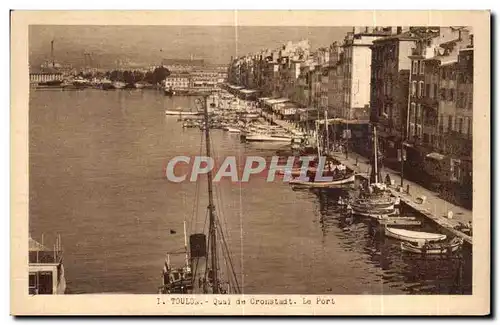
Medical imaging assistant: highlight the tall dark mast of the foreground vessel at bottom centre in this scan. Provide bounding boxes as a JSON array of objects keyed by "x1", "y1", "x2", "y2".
[{"x1": 203, "y1": 95, "x2": 219, "y2": 294}]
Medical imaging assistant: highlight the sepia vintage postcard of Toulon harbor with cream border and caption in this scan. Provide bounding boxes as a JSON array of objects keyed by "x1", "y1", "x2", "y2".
[{"x1": 10, "y1": 10, "x2": 491, "y2": 315}]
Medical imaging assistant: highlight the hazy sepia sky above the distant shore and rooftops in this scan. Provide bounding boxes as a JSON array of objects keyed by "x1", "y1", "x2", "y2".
[{"x1": 29, "y1": 25, "x2": 352, "y2": 69}]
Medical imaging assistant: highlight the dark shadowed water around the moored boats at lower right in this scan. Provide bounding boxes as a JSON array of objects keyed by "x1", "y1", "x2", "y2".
[{"x1": 304, "y1": 185, "x2": 472, "y2": 294}]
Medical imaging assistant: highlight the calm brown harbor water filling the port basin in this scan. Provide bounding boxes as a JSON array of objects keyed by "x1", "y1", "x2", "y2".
[{"x1": 29, "y1": 89, "x2": 472, "y2": 294}]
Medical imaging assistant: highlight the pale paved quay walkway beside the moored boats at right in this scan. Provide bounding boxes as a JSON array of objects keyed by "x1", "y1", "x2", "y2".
[{"x1": 330, "y1": 152, "x2": 472, "y2": 246}]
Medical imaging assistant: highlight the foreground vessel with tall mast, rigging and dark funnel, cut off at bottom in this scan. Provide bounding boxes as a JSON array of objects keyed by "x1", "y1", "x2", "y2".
[{"x1": 159, "y1": 95, "x2": 241, "y2": 294}]
